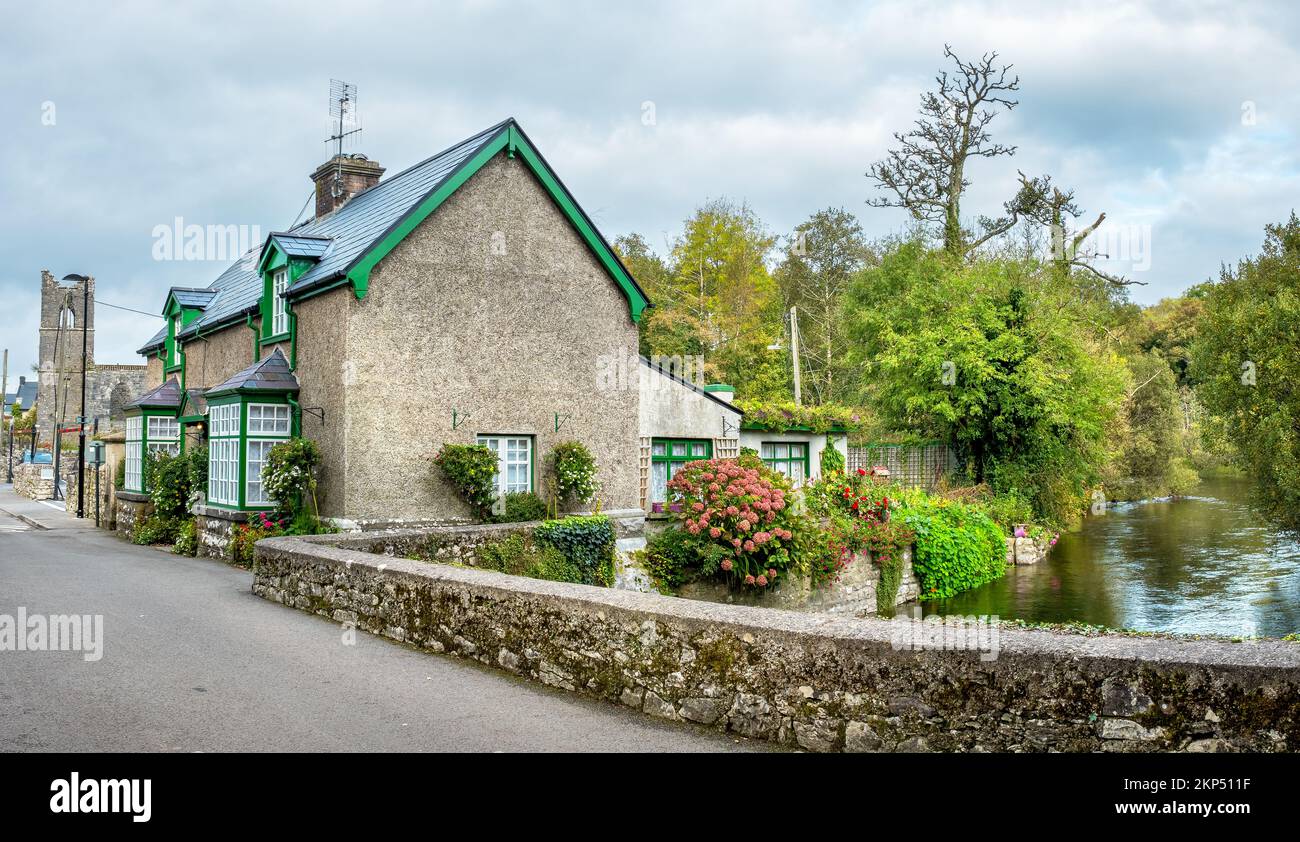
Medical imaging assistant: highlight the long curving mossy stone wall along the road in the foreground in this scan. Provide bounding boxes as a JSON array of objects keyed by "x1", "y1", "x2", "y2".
[{"x1": 254, "y1": 531, "x2": 1300, "y2": 751}]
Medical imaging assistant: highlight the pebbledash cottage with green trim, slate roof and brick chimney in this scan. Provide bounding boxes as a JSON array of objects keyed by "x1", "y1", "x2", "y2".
[{"x1": 120, "y1": 120, "x2": 650, "y2": 545}]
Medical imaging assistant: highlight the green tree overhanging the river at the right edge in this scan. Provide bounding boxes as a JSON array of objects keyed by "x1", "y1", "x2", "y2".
[{"x1": 1190, "y1": 212, "x2": 1300, "y2": 528}]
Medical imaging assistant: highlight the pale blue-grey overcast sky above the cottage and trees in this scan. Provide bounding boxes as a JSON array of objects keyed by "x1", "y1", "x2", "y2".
[{"x1": 0, "y1": 0, "x2": 1300, "y2": 371}]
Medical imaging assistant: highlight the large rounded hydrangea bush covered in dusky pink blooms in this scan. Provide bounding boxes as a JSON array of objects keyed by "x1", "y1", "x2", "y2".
[{"x1": 668, "y1": 457, "x2": 803, "y2": 587}]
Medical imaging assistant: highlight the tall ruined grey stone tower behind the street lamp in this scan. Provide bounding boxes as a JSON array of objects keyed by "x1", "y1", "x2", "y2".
[{"x1": 36, "y1": 269, "x2": 95, "y2": 440}]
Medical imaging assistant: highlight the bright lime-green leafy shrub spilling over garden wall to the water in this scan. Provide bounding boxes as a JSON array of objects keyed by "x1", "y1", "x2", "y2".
[{"x1": 898, "y1": 499, "x2": 1006, "y2": 600}]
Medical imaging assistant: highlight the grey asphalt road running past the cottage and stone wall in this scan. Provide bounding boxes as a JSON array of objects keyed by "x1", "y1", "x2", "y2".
[{"x1": 0, "y1": 512, "x2": 763, "y2": 752}]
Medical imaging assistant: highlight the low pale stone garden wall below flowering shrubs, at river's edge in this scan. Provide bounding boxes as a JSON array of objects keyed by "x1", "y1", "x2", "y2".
[{"x1": 677, "y1": 547, "x2": 920, "y2": 617}]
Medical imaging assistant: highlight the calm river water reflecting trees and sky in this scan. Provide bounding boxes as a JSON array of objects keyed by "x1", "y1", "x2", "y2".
[{"x1": 924, "y1": 478, "x2": 1300, "y2": 637}]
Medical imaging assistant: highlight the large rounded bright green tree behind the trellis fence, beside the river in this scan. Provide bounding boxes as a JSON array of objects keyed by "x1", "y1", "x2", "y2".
[{"x1": 846, "y1": 242, "x2": 1127, "y2": 522}]
